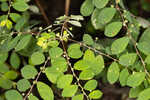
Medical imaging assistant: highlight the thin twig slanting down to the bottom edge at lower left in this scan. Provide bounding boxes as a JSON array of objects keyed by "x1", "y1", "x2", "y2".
[{"x1": 23, "y1": 57, "x2": 50, "y2": 100}]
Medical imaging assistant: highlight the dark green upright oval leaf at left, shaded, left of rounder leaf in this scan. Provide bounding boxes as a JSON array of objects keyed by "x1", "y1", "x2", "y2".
[{"x1": 10, "y1": 52, "x2": 21, "y2": 69}]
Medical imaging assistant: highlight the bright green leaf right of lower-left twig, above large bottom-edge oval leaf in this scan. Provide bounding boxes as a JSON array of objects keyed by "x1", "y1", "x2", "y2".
[{"x1": 45, "y1": 67, "x2": 63, "y2": 83}]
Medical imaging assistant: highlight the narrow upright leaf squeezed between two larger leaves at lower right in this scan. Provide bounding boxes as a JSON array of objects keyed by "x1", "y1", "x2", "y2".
[{"x1": 119, "y1": 68, "x2": 129, "y2": 86}]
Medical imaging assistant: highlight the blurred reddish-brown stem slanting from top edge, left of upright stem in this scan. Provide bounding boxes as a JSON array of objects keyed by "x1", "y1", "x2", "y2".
[{"x1": 35, "y1": 0, "x2": 50, "y2": 25}]
